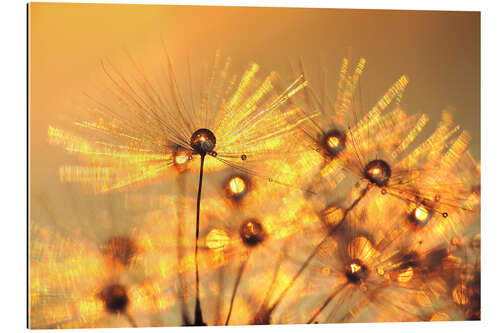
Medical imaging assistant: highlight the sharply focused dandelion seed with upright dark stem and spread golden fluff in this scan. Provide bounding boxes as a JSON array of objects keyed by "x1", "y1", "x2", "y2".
[{"x1": 49, "y1": 48, "x2": 305, "y2": 325}]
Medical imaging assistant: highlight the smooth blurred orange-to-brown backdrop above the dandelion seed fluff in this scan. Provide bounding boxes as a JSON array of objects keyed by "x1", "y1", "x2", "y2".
[{"x1": 29, "y1": 3, "x2": 480, "y2": 195}]
